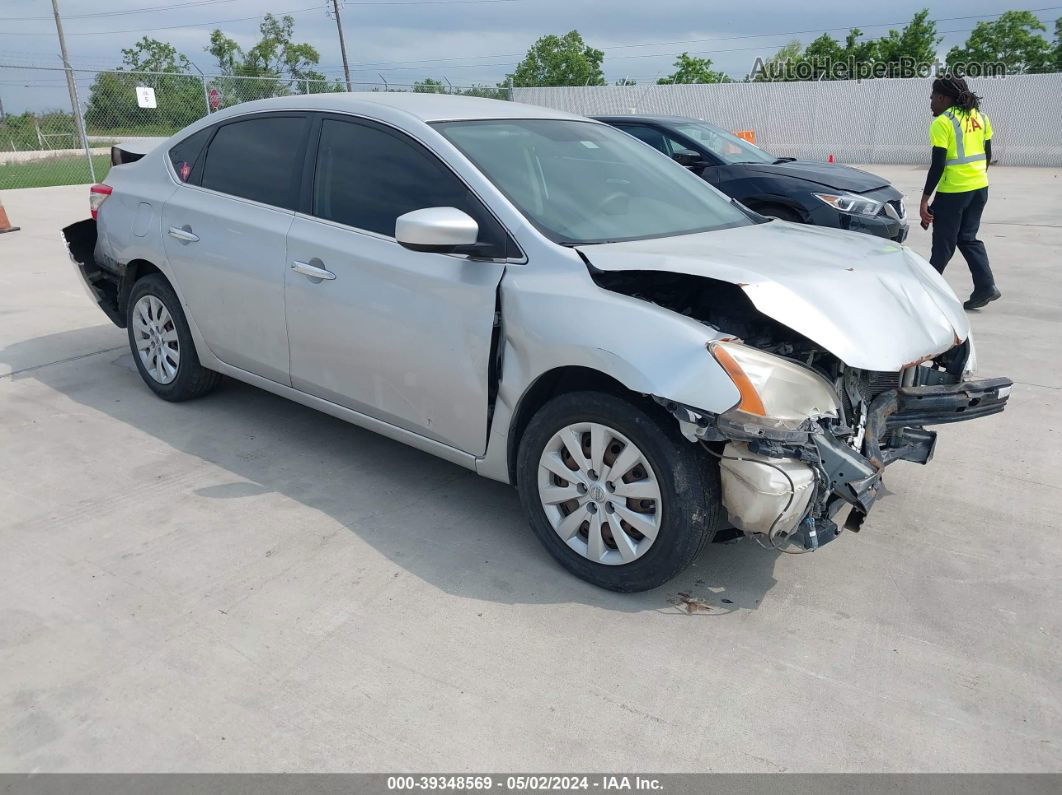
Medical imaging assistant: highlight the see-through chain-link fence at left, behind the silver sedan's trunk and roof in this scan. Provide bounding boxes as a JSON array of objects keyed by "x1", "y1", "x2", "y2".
[{"x1": 0, "y1": 65, "x2": 508, "y2": 190}]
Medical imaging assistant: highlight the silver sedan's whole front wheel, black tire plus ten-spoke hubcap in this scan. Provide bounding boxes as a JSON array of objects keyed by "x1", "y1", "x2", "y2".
[{"x1": 517, "y1": 392, "x2": 721, "y2": 591}]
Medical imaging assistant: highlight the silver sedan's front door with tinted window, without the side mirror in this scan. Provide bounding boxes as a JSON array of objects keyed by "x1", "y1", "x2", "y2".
[{"x1": 286, "y1": 117, "x2": 508, "y2": 454}]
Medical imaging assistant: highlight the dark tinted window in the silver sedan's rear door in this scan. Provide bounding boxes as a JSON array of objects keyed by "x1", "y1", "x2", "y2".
[{"x1": 203, "y1": 116, "x2": 306, "y2": 208}]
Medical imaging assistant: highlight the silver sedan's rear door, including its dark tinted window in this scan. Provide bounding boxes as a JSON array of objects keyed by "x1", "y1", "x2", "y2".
[{"x1": 162, "y1": 113, "x2": 309, "y2": 383}]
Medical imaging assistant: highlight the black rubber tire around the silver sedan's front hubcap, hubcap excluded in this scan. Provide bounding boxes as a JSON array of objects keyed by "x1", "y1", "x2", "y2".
[{"x1": 517, "y1": 392, "x2": 721, "y2": 591}]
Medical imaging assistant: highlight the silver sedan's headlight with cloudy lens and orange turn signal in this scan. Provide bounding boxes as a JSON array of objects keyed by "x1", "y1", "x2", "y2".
[{"x1": 708, "y1": 342, "x2": 841, "y2": 430}]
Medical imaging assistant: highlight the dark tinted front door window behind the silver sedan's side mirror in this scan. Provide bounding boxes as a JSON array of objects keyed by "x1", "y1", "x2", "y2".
[{"x1": 313, "y1": 119, "x2": 504, "y2": 256}]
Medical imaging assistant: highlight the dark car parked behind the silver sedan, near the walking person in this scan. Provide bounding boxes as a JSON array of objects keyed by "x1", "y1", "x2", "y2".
[{"x1": 595, "y1": 116, "x2": 907, "y2": 243}]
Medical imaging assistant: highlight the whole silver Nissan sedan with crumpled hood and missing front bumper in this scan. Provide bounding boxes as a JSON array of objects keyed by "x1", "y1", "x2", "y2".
[{"x1": 64, "y1": 93, "x2": 1011, "y2": 591}]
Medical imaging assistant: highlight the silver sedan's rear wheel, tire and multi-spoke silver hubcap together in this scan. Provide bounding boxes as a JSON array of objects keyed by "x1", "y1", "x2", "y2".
[{"x1": 125, "y1": 273, "x2": 221, "y2": 402}]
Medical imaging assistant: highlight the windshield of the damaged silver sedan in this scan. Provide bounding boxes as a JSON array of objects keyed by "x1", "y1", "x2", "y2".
[{"x1": 434, "y1": 119, "x2": 753, "y2": 245}]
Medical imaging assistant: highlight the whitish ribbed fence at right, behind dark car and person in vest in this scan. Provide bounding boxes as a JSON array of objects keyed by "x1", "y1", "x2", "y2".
[{"x1": 513, "y1": 73, "x2": 1062, "y2": 167}]
